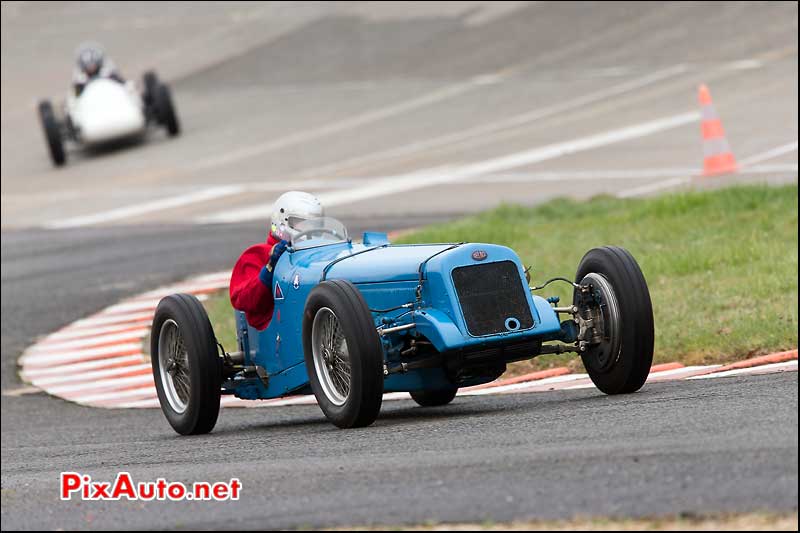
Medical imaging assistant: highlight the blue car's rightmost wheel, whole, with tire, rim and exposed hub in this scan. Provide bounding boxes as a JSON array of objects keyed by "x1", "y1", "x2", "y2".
[{"x1": 573, "y1": 246, "x2": 655, "y2": 394}]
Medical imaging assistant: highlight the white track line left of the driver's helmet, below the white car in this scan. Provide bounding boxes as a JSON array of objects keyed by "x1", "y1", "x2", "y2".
[{"x1": 44, "y1": 185, "x2": 244, "y2": 229}]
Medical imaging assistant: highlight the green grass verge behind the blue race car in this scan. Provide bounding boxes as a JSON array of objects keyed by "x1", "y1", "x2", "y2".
[{"x1": 198, "y1": 185, "x2": 798, "y2": 375}]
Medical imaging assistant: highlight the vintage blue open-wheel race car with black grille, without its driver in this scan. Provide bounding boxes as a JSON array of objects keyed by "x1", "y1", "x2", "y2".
[{"x1": 151, "y1": 217, "x2": 654, "y2": 435}]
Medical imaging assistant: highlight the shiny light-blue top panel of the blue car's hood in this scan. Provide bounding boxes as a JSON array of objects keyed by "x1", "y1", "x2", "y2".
[{"x1": 325, "y1": 244, "x2": 453, "y2": 283}]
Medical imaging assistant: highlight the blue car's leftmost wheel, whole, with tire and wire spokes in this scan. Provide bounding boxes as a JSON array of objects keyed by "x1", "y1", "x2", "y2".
[{"x1": 150, "y1": 294, "x2": 222, "y2": 435}]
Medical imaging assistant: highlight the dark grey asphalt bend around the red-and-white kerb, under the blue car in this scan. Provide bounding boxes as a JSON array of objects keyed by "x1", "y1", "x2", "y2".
[{"x1": 0, "y1": 220, "x2": 798, "y2": 529}]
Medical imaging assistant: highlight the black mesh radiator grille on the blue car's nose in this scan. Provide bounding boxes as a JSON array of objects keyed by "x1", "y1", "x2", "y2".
[{"x1": 453, "y1": 261, "x2": 533, "y2": 336}]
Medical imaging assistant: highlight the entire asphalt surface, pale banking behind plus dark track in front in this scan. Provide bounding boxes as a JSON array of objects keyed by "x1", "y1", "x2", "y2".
[{"x1": 0, "y1": 2, "x2": 798, "y2": 529}]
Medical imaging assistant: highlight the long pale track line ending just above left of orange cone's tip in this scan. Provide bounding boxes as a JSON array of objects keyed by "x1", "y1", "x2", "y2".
[{"x1": 288, "y1": 65, "x2": 686, "y2": 183}]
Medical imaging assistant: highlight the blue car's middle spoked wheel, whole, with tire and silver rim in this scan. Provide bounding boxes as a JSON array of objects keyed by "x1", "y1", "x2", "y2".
[{"x1": 303, "y1": 280, "x2": 383, "y2": 428}]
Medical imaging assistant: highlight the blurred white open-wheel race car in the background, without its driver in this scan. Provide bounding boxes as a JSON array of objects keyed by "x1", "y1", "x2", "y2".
[{"x1": 39, "y1": 72, "x2": 180, "y2": 166}]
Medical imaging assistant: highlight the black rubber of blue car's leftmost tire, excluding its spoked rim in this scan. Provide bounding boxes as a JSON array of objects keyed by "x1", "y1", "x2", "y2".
[{"x1": 150, "y1": 294, "x2": 222, "y2": 435}]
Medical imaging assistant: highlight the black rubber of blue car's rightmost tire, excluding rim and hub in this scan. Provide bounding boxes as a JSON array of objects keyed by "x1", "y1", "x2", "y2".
[{"x1": 574, "y1": 246, "x2": 655, "y2": 394}]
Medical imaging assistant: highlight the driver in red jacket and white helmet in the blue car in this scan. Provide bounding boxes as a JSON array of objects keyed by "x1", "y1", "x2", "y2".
[{"x1": 230, "y1": 191, "x2": 323, "y2": 330}]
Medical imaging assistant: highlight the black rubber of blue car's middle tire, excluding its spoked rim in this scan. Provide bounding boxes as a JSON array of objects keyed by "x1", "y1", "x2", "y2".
[{"x1": 303, "y1": 280, "x2": 383, "y2": 428}]
